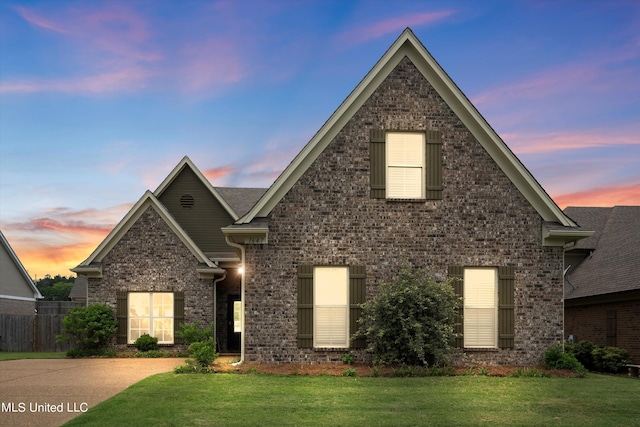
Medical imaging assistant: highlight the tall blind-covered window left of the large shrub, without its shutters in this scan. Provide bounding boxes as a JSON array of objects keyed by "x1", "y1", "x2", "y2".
[{"x1": 313, "y1": 267, "x2": 349, "y2": 348}]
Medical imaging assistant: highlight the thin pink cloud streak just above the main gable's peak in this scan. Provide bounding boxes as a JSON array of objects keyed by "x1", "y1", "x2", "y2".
[{"x1": 337, "y1": 10, "x2": 456, "y2": 46}]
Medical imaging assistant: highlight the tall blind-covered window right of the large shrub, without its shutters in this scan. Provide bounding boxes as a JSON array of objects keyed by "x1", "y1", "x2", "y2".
[{"x1": 464, "y1": 268, "x2": 498, "y2": 348}]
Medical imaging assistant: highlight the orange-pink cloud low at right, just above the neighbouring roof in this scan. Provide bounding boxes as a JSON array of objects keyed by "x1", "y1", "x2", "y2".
[{"x1": 553, "y1": 184, "x2": 640, "y2": 209}]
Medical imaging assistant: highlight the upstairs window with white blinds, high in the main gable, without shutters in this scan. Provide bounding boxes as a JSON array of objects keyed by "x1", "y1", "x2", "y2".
[{"x1": 385, "y1": 132, "x2": 425, "y2": 199}]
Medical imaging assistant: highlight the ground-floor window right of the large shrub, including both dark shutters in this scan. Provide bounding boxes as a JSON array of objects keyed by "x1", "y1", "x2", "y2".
[{"x1": 449, "y1": 266, "x2": 515, "y2": 349}]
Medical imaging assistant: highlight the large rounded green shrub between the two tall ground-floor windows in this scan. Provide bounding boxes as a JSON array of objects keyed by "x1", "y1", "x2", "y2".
[{"x1": 357, "y1": 266, "x2": 458, "y2": 366}]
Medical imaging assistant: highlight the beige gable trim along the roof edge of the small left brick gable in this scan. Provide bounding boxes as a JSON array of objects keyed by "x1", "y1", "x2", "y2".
[{"x1": 71, "y1": 191, "x2": 224, "y2": 277}]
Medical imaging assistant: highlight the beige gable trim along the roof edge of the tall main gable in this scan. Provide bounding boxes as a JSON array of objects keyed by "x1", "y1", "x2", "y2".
[{"x1": 232, "y1": 28, "x2": 590, "y2": 245}]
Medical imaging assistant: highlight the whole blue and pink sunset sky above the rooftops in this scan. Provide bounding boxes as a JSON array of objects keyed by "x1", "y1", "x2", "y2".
[{"x1": 0, "y1": 0, "x2": 640, "y2": 278}]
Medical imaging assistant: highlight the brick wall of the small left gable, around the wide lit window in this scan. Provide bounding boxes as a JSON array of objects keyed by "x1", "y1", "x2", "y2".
[{"x1": 87, "y1": 207, "x2": 213, "y2": 352}]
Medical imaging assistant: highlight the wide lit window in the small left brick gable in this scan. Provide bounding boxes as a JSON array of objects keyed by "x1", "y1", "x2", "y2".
[{"x1": 127, "y1": 292, "x2": 174, "y2": 344}]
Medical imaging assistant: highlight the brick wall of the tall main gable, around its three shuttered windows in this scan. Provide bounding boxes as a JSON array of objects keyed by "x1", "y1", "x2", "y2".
[{"x1": 245, "y1": 58, "x2": 563, "y2": 365}]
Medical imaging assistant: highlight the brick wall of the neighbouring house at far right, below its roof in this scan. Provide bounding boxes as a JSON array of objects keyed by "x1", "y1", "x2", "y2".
[{"x1": 564, "y1": 300, "x2": 640, "y2": 363}]
